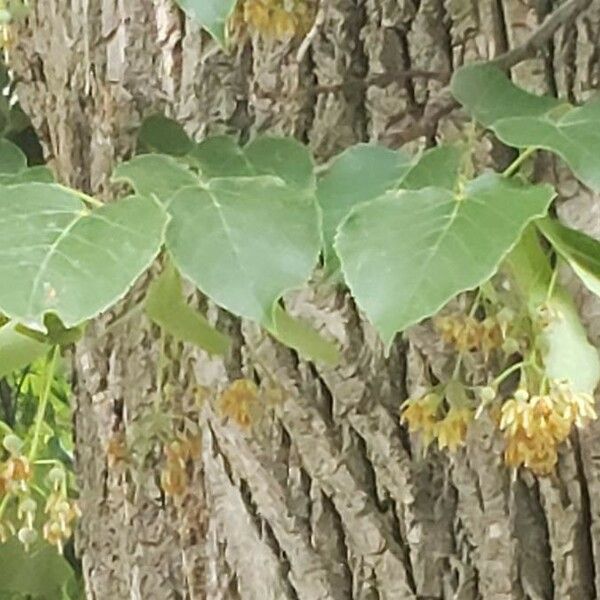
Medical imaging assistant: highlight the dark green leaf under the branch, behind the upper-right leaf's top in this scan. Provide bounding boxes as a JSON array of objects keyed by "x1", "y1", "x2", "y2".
[{"x1": 450, "y1": 63, "x2": 561, "y2": 127}]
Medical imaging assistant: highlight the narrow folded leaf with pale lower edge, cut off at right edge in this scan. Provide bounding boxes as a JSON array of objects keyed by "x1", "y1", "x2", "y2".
[{"x1": 537, "y1": 218, "x2": 600, "y2": 297}]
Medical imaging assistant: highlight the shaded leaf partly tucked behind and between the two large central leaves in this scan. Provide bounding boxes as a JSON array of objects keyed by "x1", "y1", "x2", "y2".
[{"x1": 317, "y1": 144, "x2": 412, "y2": 268}]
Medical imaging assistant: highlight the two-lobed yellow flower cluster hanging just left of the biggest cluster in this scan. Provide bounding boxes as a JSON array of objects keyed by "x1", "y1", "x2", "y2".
[{"x1": 402, "y1": 392, "x2": 473, "y2": 452}]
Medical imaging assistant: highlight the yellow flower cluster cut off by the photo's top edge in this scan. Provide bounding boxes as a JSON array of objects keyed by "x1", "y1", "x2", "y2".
[{"x1": 232, "y1": 0, "x2": 317, "y2": 39}]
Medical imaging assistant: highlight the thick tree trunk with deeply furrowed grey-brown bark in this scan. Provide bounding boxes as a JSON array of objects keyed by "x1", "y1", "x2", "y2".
[{"x1": 10, "y1": 0, "x2": 600, "y2": 600}]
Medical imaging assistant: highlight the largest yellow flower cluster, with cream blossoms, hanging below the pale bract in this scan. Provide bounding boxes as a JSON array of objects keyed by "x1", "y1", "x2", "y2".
[{"x1": 500, "y1": 382, "x2": 597, "y2": 475}]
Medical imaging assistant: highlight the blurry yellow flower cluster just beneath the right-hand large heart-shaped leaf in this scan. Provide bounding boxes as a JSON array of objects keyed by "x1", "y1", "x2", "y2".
[{"x1": 434, "y1": 313, "x2": 510, "y2": 357}]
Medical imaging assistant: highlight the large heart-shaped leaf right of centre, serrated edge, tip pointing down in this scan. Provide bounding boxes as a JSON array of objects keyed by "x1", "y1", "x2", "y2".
[{"x1": 336, "y1": 173, "x2": 554, "y2": 345}]
